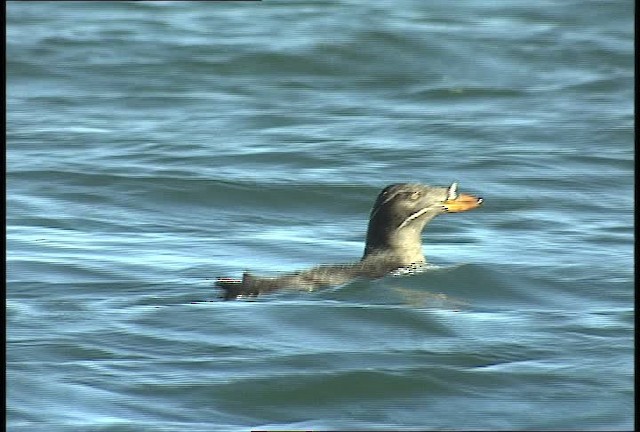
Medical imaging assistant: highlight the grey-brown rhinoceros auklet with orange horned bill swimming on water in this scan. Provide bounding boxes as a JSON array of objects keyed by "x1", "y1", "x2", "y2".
[{"x1": 217, "y1": 183, "x2": 483, "y2": 300}]
